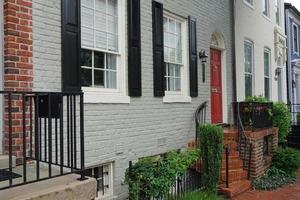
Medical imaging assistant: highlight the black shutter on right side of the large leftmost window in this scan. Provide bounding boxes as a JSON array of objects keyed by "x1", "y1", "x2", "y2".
[{"x1": 128, "y1": 0, "x2": 142, "y2": 97}]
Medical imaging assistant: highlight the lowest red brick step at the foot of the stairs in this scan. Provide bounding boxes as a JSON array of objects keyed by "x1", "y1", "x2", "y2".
[{"x1": 218, "y1": 180, "x2": 251, "y2": 198}]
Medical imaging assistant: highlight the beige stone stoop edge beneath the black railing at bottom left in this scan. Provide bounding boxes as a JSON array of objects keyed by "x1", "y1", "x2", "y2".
[{"x1": 0, "y1": 174, "x2": 97, "y2": 200}]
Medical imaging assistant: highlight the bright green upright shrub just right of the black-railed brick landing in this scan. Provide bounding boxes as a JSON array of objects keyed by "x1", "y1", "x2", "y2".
[{"x1": 273, "y1": 102, "x2": 292, "y2": 143}]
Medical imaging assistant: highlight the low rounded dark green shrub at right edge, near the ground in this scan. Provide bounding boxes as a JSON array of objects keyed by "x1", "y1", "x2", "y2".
[{"x1": 272, "y1": 148, "x2": 300, "y2": 176}]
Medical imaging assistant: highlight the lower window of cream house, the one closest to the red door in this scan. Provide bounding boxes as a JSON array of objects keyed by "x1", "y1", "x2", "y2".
[{"x1": 244, "y1": 40, "x2": 254, "y2": 98}]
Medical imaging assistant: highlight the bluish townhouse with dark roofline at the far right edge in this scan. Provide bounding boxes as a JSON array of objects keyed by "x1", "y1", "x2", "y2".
[{"x1": 285, "y1": 3, "x2": 300, "y2": 122}]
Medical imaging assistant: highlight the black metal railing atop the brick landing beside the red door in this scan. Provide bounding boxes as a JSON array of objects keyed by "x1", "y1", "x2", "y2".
[{"x1": 233, "y1": 102, "x2": 273, "y2": 131}]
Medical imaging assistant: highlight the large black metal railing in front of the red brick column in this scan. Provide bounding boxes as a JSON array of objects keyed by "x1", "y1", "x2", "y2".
[{"x1": 0, "y1": 91, "x2": 85, "y2": 190}]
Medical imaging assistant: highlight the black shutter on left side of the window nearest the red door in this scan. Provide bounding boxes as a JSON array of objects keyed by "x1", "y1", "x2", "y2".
[{"x1": 152, "y1": 1, "x2": 165, "y2": 97}]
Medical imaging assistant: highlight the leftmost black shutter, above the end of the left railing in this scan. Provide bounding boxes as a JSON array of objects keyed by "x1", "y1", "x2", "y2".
[{"x1": 62, "y1": 0, "x2": 81, "y2": 92}]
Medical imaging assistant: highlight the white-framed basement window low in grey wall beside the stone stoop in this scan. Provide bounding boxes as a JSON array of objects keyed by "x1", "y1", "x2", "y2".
[{"x1": 85, "y1": 163, "x2": 113, "y2": 200}]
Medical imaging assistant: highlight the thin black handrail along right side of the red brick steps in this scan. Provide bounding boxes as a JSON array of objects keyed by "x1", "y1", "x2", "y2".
[{"x1": 237, "y1": 102, "x2": 253, "y2": 179}]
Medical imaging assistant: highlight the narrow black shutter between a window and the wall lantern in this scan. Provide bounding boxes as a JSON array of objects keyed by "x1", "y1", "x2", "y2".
[{"x1": 189, "y1": 16, "x2": 198, "y2": 97}]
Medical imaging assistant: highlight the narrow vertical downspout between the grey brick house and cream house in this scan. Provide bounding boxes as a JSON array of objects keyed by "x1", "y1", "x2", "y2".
[{"x1": 231, "y1": 0, "x2": 237, "y2": 102}]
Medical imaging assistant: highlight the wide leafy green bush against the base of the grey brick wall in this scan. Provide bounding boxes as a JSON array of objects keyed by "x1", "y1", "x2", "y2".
[{"x1": 125, "y1": 150, "x2": 199, "y2": 200}]
